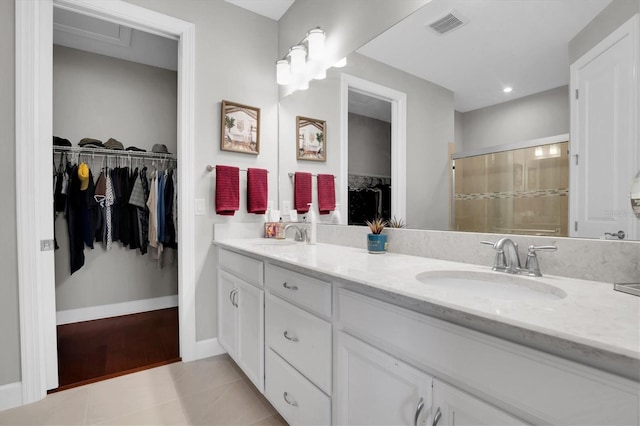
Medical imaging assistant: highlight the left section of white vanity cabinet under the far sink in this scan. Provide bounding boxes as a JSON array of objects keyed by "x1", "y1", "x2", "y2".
[{"x1": 218, "y1": 249, "x2": 264, "y2": 392}]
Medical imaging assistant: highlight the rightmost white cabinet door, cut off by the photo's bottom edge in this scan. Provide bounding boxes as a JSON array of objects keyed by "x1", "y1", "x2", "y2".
[{"x1": 431, "y1": 379, "x2": 526, "y2": 426}]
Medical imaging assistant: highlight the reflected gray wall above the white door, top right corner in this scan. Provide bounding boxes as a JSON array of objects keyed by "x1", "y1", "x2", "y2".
[{"x1": 569, "y1": 0, "x2": 640, "y2": 64}]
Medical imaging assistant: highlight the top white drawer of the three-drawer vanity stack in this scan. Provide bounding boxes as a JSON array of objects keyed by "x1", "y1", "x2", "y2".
[{"x1": 265, "y1": 265, "x2": 331, "y2": 318}]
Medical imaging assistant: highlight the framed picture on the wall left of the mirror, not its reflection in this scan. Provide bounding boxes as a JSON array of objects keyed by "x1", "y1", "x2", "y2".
[{"x1": 220, "y1": 101, "x2": 260, "y2": 155}]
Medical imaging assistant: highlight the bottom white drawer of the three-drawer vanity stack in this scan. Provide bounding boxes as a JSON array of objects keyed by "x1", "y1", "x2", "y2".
[{"x1": 265, "y1": 349, "x2": 331, "y2": 425}]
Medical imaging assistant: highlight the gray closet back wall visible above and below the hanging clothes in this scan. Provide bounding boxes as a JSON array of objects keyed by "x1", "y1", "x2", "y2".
[{"x1": 53, "y1": 46, "x2": 178, "y2": 311}]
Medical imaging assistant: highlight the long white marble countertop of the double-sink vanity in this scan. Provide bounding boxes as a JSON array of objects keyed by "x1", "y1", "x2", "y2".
[{"x1": 214, "y1": 238, "x2": 640, "y2": 381}]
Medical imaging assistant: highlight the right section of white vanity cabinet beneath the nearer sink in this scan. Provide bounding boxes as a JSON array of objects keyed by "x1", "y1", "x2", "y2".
[{"x1": 333, "y1": 288, "x2": 640, "y2": 425}]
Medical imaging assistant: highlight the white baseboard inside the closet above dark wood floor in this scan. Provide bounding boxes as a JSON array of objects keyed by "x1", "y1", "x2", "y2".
[{"x1": 56, "y1": 294, "x2": 178, "y2": 325}]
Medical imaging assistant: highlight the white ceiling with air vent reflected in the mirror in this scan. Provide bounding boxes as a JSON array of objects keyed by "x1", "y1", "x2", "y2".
[{"x1": 357, "y1": 0, "x2": 611, "y2": 112}]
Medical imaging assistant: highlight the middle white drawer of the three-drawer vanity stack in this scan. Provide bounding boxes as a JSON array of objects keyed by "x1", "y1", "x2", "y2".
[{"x1": 265, "y1": 294, "x2": 331, "y2": 394}]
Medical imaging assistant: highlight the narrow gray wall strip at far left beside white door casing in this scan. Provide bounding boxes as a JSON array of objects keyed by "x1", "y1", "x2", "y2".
[{"x1": 0, "y1": 1, "x2": 20, "y2": 386}]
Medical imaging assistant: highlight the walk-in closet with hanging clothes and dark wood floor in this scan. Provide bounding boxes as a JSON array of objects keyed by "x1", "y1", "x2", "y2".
[{"x1": 52, "y1": 8, "x2": 180, "y2": 388}]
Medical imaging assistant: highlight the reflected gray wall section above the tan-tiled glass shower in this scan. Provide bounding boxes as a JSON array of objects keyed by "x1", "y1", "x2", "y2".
[{"x1": 456, "y1": 86, "x2": 570, "y2": 152}]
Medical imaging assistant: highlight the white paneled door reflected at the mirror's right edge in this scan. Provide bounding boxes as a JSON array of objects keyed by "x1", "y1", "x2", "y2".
[{"x1": 569, "y1": 15, "x2": 640, "y2": 239}]
